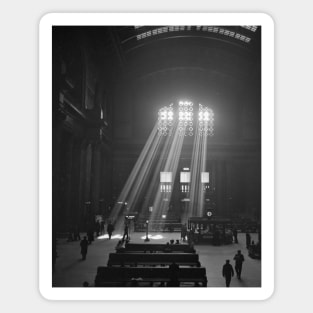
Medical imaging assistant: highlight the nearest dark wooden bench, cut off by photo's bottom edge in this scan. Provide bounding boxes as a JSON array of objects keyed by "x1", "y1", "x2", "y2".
[{"x1": 95, "y1": 266, "x2": 207, "y2": 287}]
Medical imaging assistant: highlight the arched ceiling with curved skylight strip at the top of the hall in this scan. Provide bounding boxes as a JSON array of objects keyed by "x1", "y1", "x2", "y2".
[{"x1": 110, "y1": 26, "x2": 261, "y2": 79}]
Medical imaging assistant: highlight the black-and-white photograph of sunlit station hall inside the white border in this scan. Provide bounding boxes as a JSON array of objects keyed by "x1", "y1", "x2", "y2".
[{"x1": 41, "y1": 12, "x2": 273, "y2": 299}]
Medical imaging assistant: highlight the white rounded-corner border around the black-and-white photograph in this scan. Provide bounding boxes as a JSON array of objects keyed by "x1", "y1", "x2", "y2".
[{"x1": 39, "y1": 13, "x2": 274, "y2": 300}]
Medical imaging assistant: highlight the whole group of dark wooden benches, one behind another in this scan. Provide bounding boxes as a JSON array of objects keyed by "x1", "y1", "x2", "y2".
[{"x1": 95, "y1": 243, "x2": 207, "y2": 287}]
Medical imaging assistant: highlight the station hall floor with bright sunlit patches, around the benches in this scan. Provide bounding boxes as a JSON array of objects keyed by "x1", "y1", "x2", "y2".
[{"x1": 53, "y1": 233, "x2": 261, "y2": 287}]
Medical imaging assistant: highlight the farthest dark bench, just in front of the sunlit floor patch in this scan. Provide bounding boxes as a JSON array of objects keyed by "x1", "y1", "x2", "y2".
[{"x1": 116, "y1": 243, "x2": 196, "y2": 253}]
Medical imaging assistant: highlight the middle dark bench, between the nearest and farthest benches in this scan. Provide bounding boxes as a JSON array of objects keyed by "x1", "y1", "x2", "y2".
[{"x1": 108, "y1": 253, "x2": 200, "y2": 267}]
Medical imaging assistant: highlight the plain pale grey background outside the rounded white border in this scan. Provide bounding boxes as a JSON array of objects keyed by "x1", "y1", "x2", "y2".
[{"x1": 0, "y1": 0, "x2": 313, "y2": 313}]
